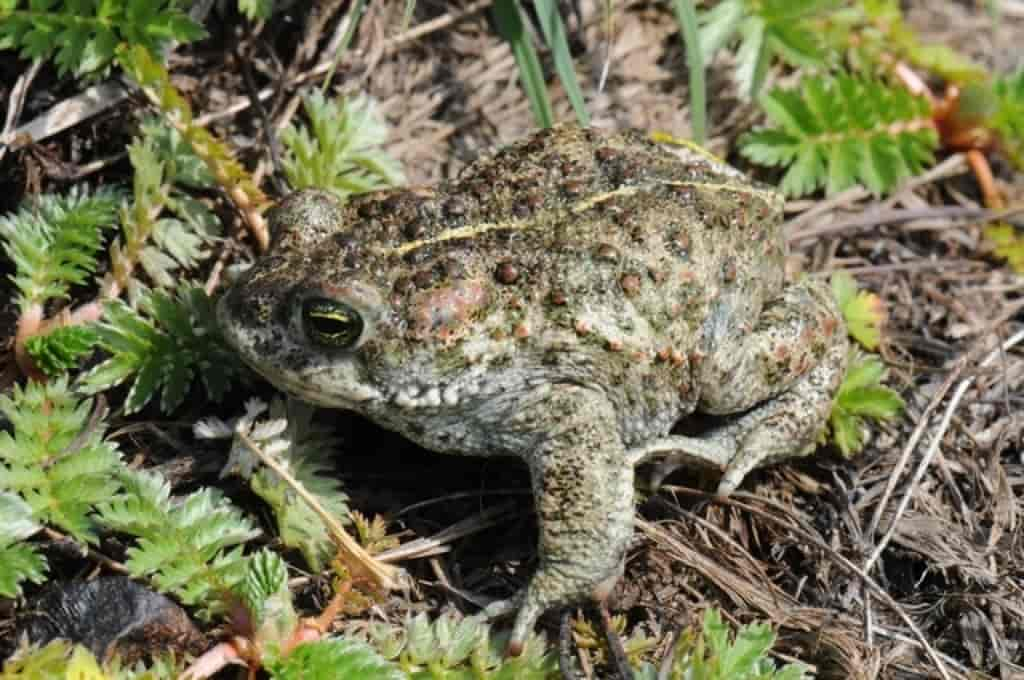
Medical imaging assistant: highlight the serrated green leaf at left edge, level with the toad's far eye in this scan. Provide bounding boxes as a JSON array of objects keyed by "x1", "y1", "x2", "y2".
[{"x1": 0, "y1": 188, "x2": 120, "y2": 312}]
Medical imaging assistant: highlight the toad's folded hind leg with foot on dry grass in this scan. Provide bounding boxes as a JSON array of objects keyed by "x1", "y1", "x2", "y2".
[{"x1": 647, "y1": 280, "x2": 849, "y2": 496}]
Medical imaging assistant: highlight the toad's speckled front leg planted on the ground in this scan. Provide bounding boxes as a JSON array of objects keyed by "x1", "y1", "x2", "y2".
[{"x1": 487, "y1": 385, "x2": 633, "y2": 654}]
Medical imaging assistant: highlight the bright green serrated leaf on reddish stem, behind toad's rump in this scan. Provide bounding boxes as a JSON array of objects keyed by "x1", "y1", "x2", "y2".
[{"x1": 739, "y1": 76, "x2": 938, "y2": 196}]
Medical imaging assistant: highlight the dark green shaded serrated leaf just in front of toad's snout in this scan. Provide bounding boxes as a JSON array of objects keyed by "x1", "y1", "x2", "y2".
[{"x1": 79, "y1": 287, "x2": 239, "y2": 413}]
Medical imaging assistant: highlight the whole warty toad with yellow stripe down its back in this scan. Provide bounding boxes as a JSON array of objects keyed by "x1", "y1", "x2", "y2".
[{"x1": 219, "y1": 127, "x2": 847, "y2": 650}]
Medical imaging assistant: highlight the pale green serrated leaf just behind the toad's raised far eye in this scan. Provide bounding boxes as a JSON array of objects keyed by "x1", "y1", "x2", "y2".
[{"x1": 281, "y1": 91, "x2": 403, "y2": 199}]
